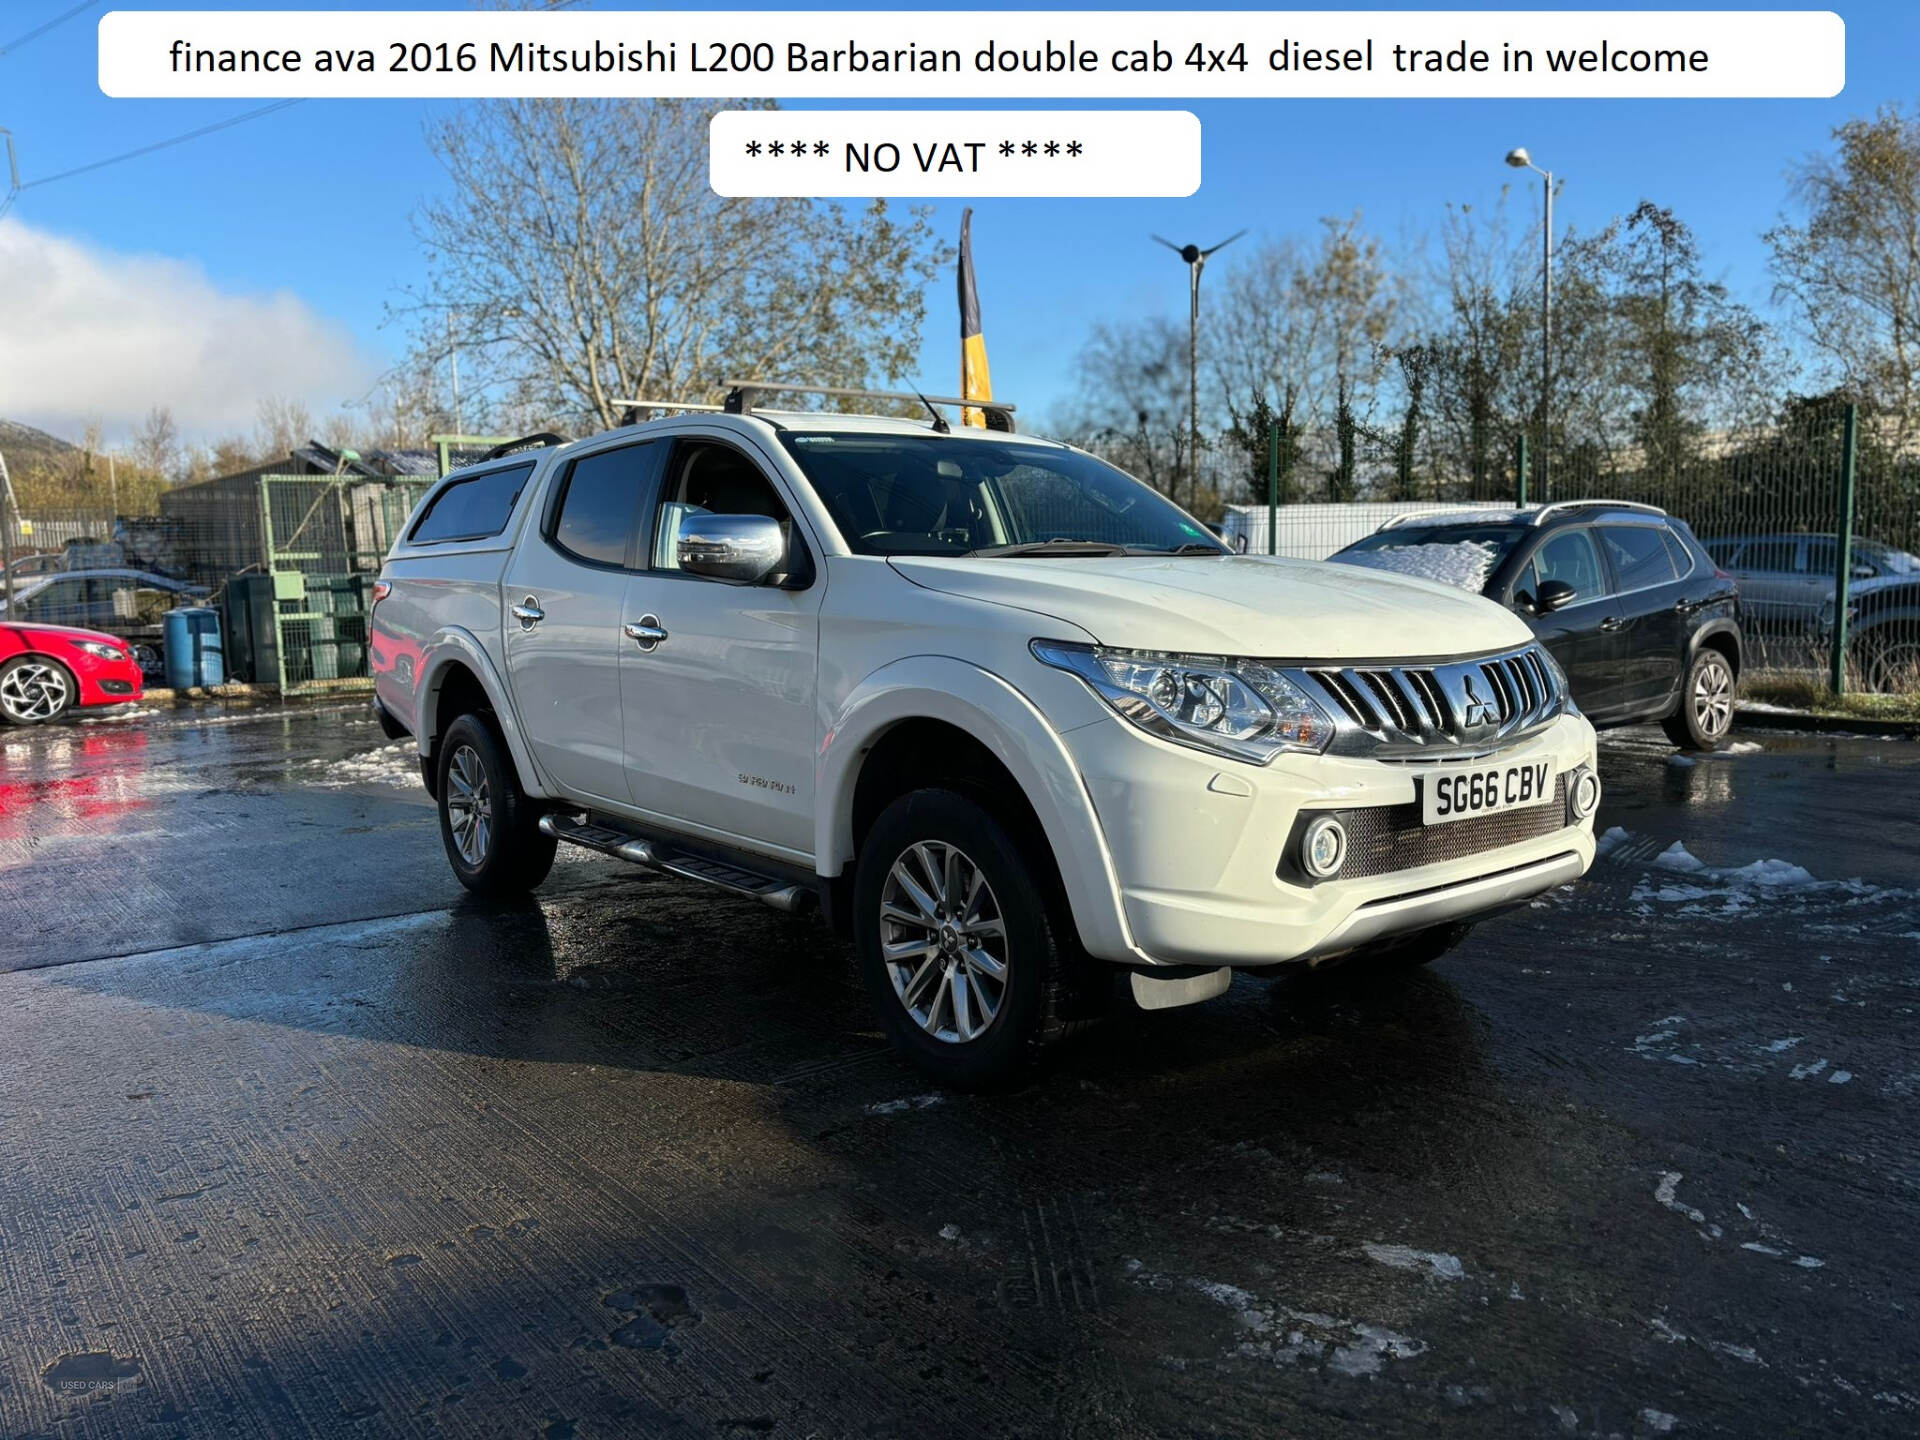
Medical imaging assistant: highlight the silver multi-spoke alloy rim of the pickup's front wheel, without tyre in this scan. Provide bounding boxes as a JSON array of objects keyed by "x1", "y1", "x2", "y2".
[{"x1": 879, "y1": 841, "x2": 1008, "y2": 1044}]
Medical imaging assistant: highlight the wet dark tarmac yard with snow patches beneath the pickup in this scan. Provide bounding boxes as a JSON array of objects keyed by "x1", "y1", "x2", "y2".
[{"x1": 0, "y1": 707, "x2": 1920, "y2": 1440}]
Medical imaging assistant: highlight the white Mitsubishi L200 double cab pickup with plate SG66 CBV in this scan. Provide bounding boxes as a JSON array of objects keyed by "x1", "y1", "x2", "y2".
[{"x1": 372, "y1": 390, "x2": 1599, "y2": 1087}]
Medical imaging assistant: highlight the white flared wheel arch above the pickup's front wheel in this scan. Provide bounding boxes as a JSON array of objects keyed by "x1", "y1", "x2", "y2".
[{"x1": 814, "y1": 655, "x2": 1150, "y2": 964}]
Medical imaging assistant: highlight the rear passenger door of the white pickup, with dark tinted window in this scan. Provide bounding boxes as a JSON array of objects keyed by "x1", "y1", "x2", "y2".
[{"x1": 501, "y1": 442, "x2": 662, "y2": 806}]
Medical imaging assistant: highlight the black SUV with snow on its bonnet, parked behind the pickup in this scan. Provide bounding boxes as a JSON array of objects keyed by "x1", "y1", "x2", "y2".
[{"x1": 1332, "y1": 501, "x2": 1741, "y2": 751}]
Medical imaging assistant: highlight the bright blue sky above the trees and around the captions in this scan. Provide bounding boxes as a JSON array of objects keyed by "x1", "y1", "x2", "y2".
[{"x1": 0, "y1": 0, "x2": 1920, "y2": 443}]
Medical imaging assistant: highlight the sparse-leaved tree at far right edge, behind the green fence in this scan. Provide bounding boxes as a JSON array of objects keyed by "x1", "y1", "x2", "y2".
[{"x1": 1766, "y1": 106, "x2": 1920, "y2": 444}]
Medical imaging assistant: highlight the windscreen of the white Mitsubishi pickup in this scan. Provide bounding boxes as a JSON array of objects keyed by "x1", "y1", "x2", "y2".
[{"x1": 780, "y1": 432, "x2": 1225, "y2": 555}]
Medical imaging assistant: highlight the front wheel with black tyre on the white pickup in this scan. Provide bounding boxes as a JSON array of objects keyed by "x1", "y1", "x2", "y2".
[{"x1": 852, "y1": 789, "x2": 1085, "y2": 1091}]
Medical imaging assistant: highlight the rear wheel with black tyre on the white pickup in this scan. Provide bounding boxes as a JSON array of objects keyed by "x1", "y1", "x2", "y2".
[{"x1": 440, "y1": 714, "x2": 559, "y2": 897}]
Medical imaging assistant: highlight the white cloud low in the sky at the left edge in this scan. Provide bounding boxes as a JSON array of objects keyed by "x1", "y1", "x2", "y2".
[{"x1": 0, "y1": 219, "x2": 380, "y2": 438}]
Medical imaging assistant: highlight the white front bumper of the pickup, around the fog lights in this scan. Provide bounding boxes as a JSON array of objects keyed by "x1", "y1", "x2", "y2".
[{"x1": 1064, "y1": 714, "x2": 1594, "y2": 968}]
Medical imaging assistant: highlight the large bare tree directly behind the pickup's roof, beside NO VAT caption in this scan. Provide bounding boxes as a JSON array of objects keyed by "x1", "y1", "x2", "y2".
[{"x1": 399, "y1": 98, "x2": 950, "y2": 428}]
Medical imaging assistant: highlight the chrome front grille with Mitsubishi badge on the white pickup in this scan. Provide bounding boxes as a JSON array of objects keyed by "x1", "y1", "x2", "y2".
[{"x1": 1286, "y1": 643, "x2": 1569, "y2": 758}]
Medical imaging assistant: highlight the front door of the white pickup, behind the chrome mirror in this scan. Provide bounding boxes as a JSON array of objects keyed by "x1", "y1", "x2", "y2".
[{"x1": 620, "y1": 436, "x2": 826, "y2": 858}]
